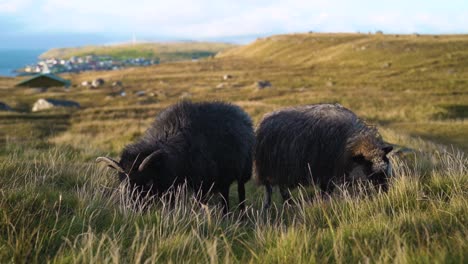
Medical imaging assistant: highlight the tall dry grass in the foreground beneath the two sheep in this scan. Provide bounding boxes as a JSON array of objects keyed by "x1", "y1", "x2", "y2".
[{"x1": 0, "y1": 140, "x2": 468, "y2": 263}]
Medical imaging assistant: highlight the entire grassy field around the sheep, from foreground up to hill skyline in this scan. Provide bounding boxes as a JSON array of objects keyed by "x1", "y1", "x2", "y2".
[{"x1": 0, "y1": 34, "x2": 468, "y2": 263}]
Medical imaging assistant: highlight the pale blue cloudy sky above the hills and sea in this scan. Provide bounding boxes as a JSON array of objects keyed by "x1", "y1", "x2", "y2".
[{"x1": 0, "y1": 0, "x2": 468, "y2": 48}]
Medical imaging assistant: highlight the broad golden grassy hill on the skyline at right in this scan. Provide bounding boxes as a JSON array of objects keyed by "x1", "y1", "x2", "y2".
[{"x1": 218, "y1": 33, "x2": 468, "y2": 67}]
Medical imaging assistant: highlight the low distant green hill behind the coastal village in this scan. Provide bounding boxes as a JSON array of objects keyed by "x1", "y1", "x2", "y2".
[{"x1": 40, "y1": 42, "x2": 236, "y2": 62}]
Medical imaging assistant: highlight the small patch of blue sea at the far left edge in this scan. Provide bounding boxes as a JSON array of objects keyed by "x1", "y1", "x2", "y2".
[{"x1": 0, "y1": 49, "x2": 46, "y2": 77}]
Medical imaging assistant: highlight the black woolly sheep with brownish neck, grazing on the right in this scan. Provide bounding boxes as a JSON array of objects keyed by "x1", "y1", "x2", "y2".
[{"x1": 255, "y1": 104, "x2": 392, "y2": 207}]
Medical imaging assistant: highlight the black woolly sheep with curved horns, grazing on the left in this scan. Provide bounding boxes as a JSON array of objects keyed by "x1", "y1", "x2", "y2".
[{"x1": 96, "y1": 101, "x2": 255, "y2": 213}]
